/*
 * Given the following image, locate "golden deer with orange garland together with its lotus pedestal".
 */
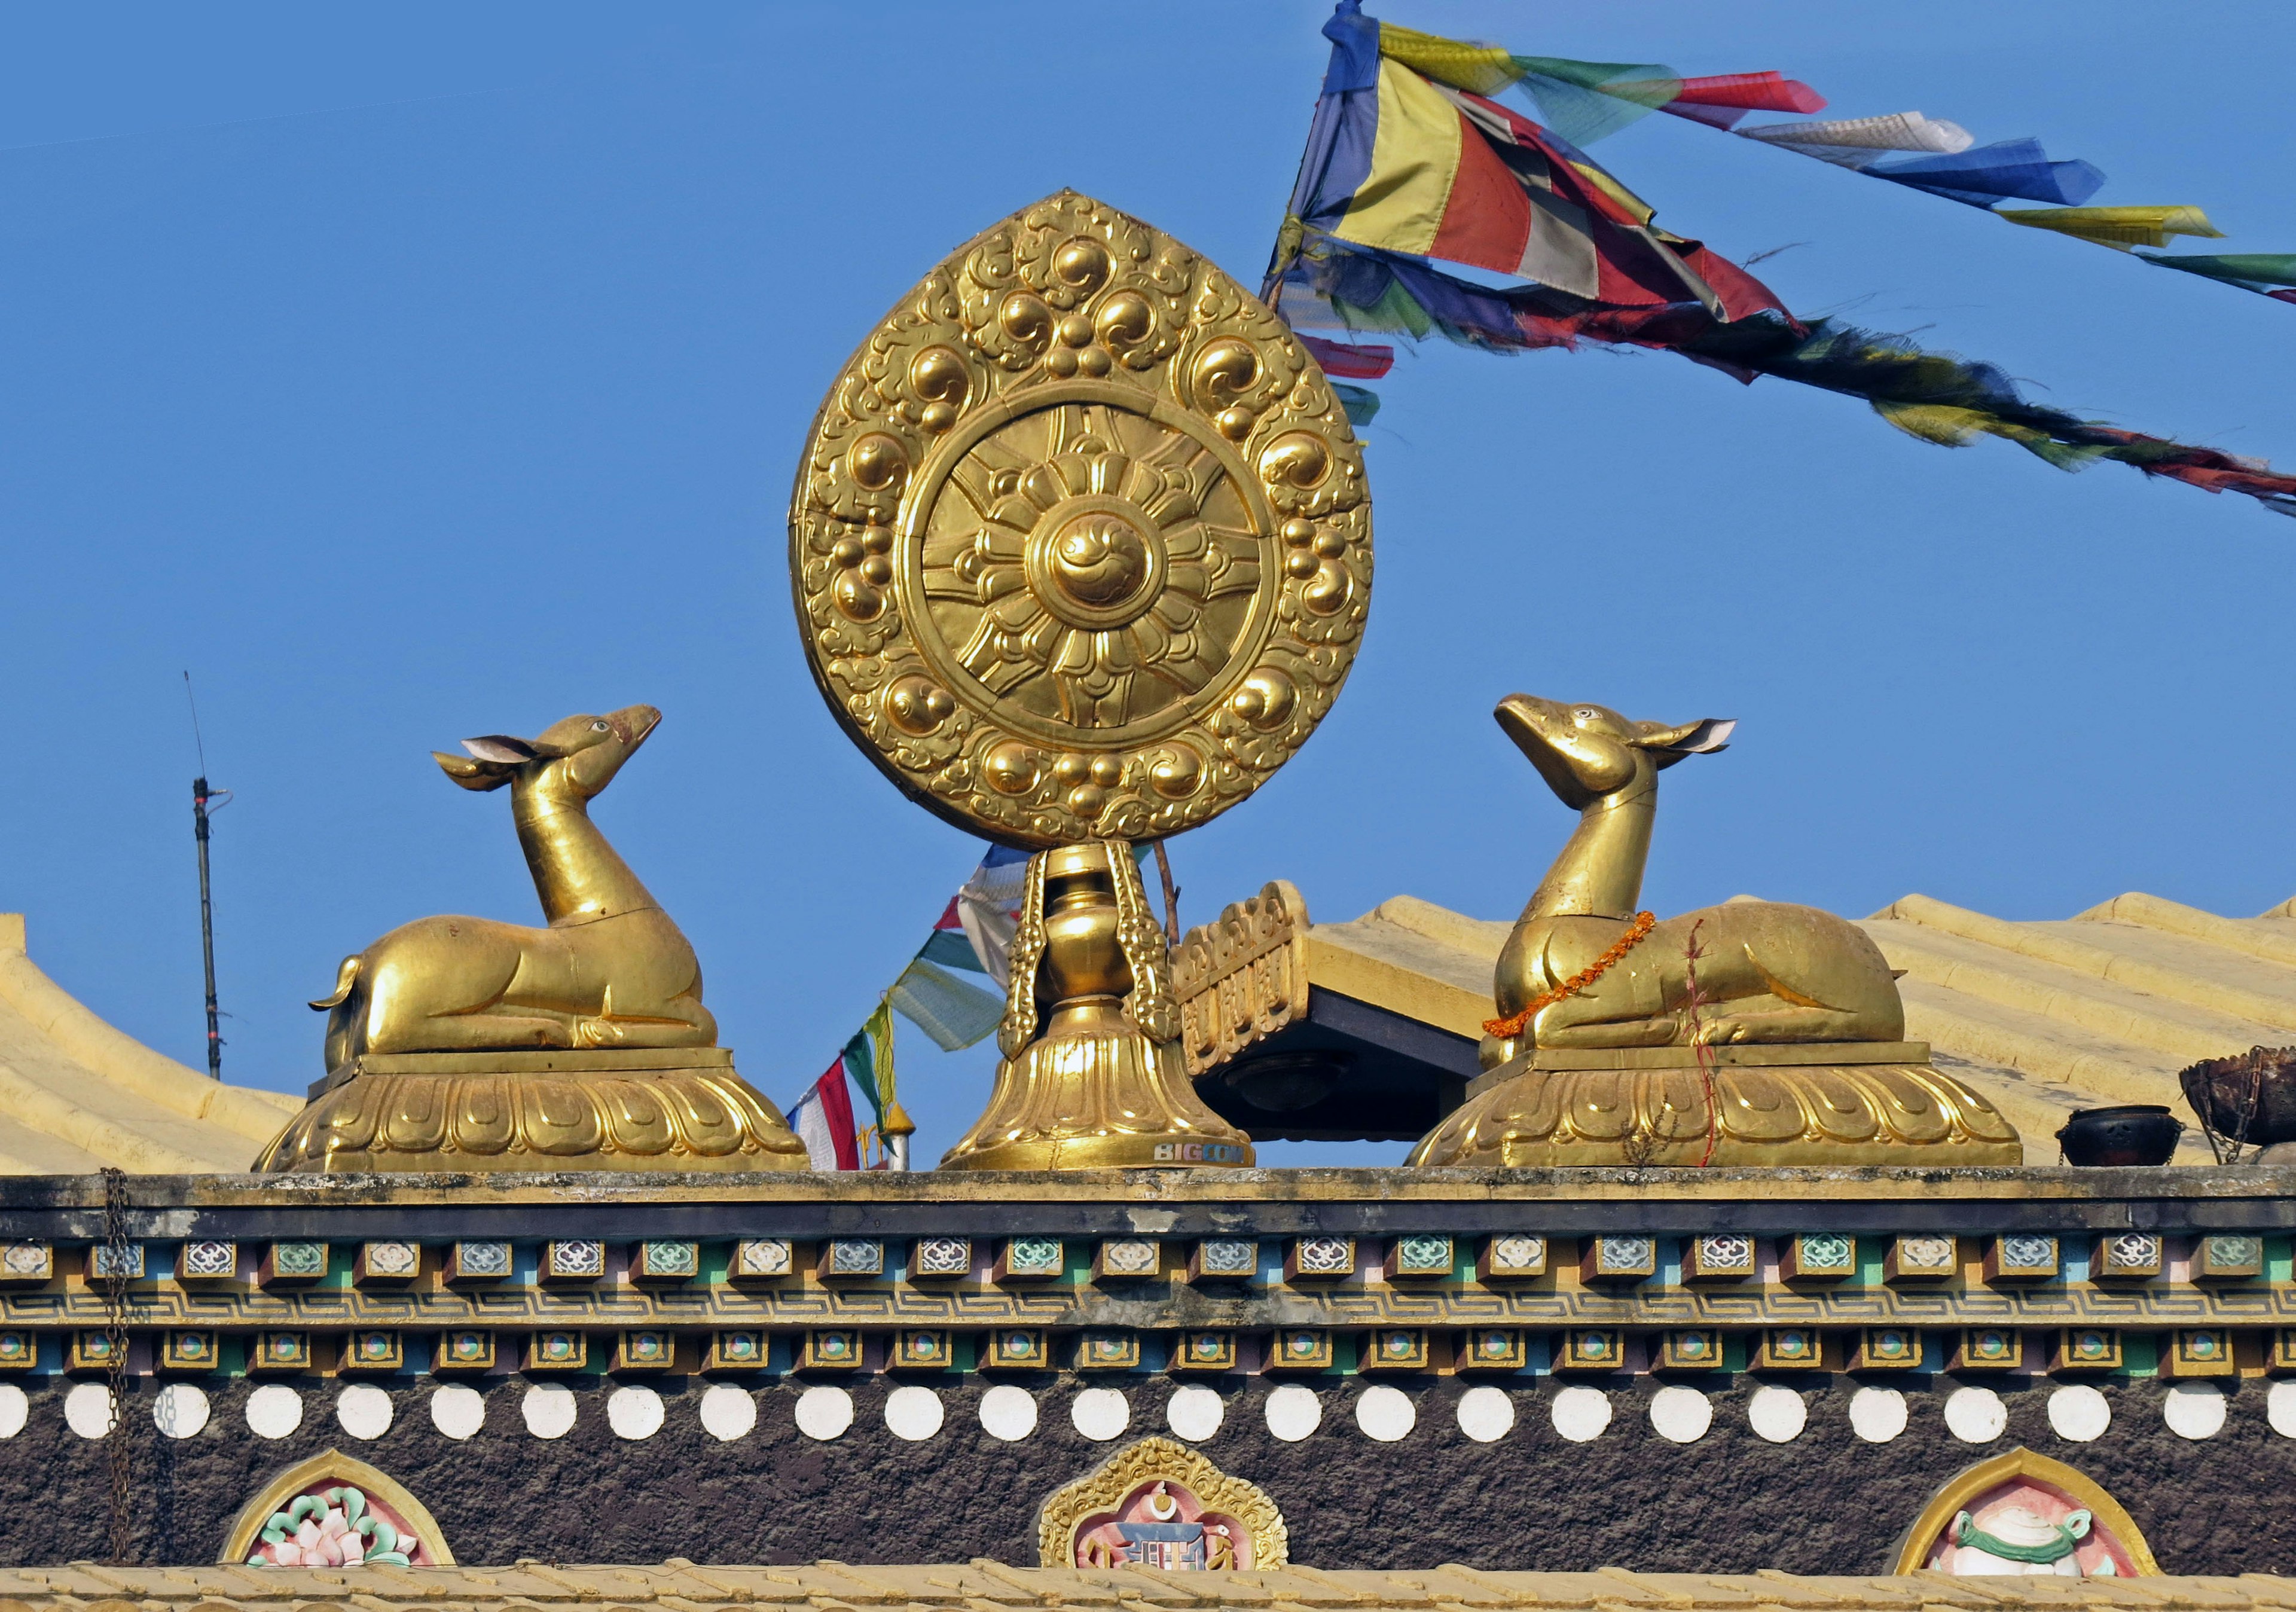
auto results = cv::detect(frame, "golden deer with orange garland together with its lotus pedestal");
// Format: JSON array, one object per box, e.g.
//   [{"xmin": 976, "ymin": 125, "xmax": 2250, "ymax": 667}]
[{"xmin": 1412, "ymin": 694, "xmax": 2023, "ymax": 1169}]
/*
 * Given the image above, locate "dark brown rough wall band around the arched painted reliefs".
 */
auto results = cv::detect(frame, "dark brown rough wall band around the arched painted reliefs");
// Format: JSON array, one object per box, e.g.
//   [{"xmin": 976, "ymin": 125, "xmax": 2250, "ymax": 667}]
[{"xmin": 0, "ymin": 1378, "xmax": 2296, "ymax": 1573}]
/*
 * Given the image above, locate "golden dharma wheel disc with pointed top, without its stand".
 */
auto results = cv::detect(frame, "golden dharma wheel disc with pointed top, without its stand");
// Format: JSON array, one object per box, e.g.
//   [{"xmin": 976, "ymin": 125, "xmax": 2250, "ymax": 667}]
[{"xmin": 790, "ymin": 191, "xmax": 1370, "ymax": 847}]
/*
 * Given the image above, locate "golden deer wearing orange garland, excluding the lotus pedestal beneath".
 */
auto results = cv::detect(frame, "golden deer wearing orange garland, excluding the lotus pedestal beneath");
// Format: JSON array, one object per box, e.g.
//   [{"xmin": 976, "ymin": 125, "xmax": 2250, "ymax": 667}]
[{"xmin": 1483, "ymin": 694, "xmax": 1906, "ymax": 1068}]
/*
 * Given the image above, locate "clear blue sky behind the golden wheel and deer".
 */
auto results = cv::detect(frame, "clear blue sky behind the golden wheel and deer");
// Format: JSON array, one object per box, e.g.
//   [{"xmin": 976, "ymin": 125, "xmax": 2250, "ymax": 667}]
[{"xmin": 0, "ymin": 0, "xmax": 2296, "ymax": 1162}]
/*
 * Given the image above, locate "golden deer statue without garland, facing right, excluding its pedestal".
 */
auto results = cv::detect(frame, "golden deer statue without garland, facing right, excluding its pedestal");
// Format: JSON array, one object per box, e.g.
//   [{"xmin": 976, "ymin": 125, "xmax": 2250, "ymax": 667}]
[{"xmin": 310, "ymin": 705, "xmax": 716, "ymax": 1070}]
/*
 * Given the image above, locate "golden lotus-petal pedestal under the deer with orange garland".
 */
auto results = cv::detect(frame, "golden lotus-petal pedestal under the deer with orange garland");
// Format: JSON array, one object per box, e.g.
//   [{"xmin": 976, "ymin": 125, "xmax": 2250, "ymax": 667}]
[{"xmin": 1410, "ymin": 1040, "xmax": 2025, "ymax": 1169}]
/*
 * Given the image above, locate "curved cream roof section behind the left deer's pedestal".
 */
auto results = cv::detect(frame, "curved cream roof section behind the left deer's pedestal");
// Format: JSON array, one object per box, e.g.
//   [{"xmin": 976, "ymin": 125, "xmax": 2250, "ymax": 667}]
[{"xmin": 0, "ymin": 912, "xmax": 303, "ymax": 1176}]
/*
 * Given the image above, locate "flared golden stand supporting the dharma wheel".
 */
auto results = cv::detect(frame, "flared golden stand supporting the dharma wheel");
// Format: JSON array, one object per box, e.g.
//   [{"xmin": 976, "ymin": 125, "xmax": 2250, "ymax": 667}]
[{"xmin": 941, "ymin": 841, "xmax": 1251, "ymax": 1169}]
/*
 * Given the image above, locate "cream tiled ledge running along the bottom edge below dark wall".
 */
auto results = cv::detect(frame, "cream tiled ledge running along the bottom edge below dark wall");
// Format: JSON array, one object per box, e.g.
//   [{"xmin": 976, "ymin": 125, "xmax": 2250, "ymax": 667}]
[{"xmin": 0, "ymin": 1557, "xmax": 2296, "ymax": 1612}]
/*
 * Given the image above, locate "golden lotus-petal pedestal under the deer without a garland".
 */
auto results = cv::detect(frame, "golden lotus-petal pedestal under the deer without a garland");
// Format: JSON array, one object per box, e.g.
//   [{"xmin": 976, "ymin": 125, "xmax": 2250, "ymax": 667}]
[{"xmin": 255, "ymin": 1047, "xmax": 806, "ymax": 1171}]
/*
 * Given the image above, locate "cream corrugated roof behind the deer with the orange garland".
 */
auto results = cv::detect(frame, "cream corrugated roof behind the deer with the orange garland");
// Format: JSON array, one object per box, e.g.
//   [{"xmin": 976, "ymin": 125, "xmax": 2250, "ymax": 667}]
[{"xmin": 1304, "ymin": 896, "xmax": 2296, "ymax": 1164}]
